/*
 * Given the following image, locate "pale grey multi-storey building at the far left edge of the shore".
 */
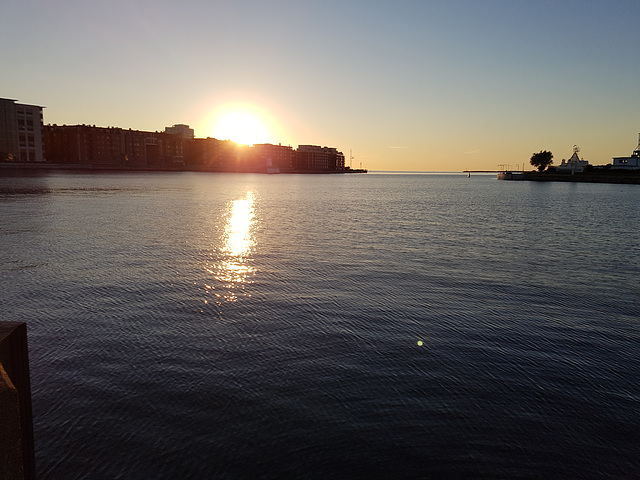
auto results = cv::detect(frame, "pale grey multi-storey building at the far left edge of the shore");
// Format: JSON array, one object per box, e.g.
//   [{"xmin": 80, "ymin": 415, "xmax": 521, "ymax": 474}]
[{"xmin": 0, "ymin": 98, "xmax": 45, "ymax": 162}]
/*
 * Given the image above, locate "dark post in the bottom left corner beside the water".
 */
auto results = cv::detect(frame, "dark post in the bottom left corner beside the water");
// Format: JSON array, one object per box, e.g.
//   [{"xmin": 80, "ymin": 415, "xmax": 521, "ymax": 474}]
[{"xmin": 0, "ymin": 322, "xmax": 35, "ymax": 480}]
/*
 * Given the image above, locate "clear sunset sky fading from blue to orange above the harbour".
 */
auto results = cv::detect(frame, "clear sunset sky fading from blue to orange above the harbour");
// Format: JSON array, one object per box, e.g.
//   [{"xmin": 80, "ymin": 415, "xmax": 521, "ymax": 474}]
[{"xmin": 0, "ymin": 0, "xmax": 640, "ymax": 171}]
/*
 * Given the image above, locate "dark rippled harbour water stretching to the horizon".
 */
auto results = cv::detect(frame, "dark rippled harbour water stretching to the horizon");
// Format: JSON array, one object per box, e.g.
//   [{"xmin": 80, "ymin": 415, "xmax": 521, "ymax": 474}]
[{"xmin": 0, "ymin": 173, "xmax": 640, "ymax": 479}]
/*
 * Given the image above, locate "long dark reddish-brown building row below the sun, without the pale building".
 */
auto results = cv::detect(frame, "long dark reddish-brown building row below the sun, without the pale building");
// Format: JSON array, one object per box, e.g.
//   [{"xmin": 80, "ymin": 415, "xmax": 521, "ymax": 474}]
[{"xmin": 43, "ymin": 125, "xmax": 345, "ymax": 173}]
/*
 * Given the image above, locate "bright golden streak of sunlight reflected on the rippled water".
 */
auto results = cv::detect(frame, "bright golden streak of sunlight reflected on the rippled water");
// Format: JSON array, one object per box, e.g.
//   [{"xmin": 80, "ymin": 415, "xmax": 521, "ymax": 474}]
[{"xmin": 206, "ymin": 192, "xmax": 256, "ymax": 302}]
